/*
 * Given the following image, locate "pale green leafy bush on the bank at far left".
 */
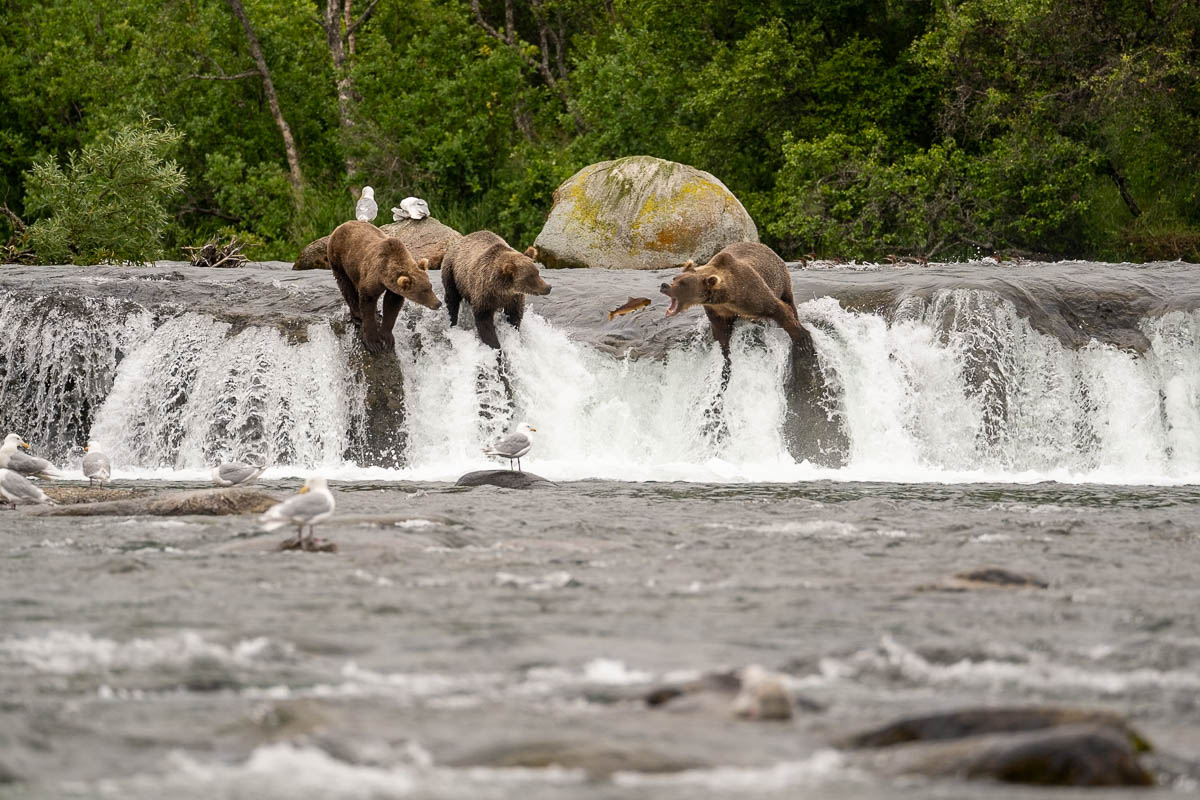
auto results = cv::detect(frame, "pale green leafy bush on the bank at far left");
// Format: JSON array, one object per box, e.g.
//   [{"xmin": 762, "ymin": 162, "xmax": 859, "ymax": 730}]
[{"xmin": 25, "ymin": 119, "xmax": 186, "ymax": 264}]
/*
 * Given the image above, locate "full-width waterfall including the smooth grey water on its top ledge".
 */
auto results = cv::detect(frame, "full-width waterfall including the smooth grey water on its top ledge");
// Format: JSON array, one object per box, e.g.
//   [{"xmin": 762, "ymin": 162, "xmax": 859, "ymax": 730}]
[{"xmin": 0, "ymin": 261, "xmax": 1200, "ymax": 483}]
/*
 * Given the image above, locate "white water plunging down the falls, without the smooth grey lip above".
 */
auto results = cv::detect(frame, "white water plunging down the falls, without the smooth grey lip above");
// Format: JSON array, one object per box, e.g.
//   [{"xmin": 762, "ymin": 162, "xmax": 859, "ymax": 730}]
[{"xmin": 0, "ymin": 266, "xmax": 1200, "ymax": 482}]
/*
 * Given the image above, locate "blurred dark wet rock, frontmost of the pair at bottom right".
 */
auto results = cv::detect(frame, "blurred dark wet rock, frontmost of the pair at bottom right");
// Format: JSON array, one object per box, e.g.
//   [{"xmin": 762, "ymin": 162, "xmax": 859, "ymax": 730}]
[{"xmin": 872, "ymin": 724, "xmax": 1154, "ymax": 787}]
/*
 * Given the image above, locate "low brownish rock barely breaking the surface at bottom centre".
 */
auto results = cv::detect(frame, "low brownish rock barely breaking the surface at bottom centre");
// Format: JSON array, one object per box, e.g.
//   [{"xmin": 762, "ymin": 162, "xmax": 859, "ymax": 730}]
[{"xmin": 450, "ymin": 741, "xmax": 702, "ymax": 778}]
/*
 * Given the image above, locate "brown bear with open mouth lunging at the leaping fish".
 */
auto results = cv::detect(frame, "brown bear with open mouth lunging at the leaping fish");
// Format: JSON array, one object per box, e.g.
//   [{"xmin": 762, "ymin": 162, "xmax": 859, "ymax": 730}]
[{"xmin": 660, "ymin": 242, "xmax": 814, "ymax": 361}]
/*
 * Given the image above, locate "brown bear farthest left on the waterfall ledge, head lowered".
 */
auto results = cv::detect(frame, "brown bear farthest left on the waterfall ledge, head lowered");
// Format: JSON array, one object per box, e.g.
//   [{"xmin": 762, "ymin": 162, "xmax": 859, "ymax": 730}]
[{"xmin": 329, "ymin": 221, "xmax": 442, "ymax": 353}]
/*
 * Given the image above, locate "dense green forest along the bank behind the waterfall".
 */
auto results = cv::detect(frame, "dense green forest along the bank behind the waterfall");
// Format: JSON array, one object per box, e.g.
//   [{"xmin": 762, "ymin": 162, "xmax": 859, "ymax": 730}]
[{"xmin": 0, "ymin": 0, "xmax": 1200, "ymax": 261}]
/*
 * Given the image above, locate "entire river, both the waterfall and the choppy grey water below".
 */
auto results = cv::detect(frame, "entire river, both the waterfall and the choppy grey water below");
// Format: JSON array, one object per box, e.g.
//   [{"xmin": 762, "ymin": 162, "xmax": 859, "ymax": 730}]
[{"xmin": 0, "ymin": 264, "xmax": 1200, "ymax": 799}]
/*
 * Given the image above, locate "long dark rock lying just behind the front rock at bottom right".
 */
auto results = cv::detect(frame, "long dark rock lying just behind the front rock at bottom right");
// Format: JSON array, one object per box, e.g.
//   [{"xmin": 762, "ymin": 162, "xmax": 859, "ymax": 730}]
[{"xmin": 838, "ymin": 708, "xmax": 1150, "ymax": 750}]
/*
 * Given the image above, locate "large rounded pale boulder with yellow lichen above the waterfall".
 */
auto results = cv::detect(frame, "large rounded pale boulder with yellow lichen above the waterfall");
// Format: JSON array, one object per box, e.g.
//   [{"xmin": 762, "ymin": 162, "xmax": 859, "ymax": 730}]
[{"xmin": 534, "ymin": 156, "xmax": 758, "ymax": 270}]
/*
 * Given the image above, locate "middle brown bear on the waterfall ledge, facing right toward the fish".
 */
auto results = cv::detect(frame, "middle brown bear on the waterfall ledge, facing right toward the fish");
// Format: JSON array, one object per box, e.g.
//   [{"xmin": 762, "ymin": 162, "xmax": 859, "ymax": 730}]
[{"xmin": 442, "ymin": 230, "xmax": 550, "ymax": 350}]
